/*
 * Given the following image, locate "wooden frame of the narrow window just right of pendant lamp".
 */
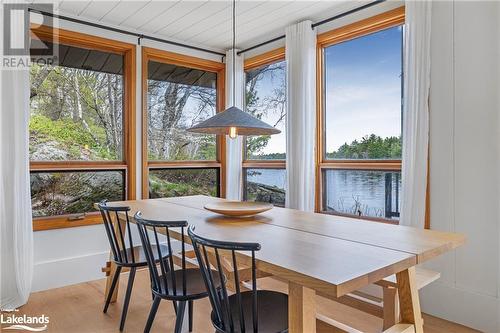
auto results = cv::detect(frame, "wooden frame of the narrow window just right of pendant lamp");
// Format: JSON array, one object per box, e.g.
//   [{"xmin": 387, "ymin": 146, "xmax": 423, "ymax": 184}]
[{"xmin": 241, "ymin": 47, "xmax": 286, "ymax": 198}]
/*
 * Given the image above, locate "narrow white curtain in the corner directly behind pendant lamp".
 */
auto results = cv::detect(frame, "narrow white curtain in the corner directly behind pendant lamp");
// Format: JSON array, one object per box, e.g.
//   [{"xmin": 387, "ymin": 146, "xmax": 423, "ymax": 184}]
[{"xmin": 226, "ymin": 50, "xmax": 245, "ymax": 200}]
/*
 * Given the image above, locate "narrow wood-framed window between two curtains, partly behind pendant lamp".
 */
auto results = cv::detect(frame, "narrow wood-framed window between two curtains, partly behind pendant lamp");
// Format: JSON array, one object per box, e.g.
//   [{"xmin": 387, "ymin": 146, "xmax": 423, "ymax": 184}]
[{"xmin": 243, "ymin": 48, "xmax": 286, "ymax": 206}]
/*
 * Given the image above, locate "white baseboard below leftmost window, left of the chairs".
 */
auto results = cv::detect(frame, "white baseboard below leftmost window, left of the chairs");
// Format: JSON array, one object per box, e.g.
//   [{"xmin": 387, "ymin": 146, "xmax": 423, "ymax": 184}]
[{"xmin": 32, "ymin": 251, "xmax": 109, "ymax": 292}]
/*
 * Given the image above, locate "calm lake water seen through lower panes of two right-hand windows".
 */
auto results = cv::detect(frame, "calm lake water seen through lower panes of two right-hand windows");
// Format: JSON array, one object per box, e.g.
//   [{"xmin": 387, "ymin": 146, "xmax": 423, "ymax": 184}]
[{"xmin": 247, "ymin": 169, "xmax": 401, "ymax": 217}]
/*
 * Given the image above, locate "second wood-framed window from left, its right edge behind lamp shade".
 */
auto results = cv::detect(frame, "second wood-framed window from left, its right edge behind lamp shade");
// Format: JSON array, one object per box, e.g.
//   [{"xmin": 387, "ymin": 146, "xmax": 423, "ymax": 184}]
[{"xmin": 143, "ymin": 48, "xmax": 224, "ymax": 198}]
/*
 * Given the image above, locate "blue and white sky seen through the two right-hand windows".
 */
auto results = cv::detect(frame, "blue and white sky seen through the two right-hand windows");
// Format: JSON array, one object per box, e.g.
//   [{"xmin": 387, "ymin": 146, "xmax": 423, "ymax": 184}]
[{"xmin": 250, "ymin": 27, "xmax": 402, "ymax": 154}]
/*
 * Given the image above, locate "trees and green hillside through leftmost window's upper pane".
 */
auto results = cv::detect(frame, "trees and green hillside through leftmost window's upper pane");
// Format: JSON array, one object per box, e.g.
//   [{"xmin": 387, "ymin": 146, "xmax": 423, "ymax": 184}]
[{"xmin": 30, "ymin": 64, "xmax": 123, "ymax": 160}]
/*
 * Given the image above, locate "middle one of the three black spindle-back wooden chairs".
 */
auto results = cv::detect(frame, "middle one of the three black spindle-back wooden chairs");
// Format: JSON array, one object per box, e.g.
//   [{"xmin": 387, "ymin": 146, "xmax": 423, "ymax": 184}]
[{"xmin": 134, "ymin": 212, "xmax": 220, "ymax": 333}]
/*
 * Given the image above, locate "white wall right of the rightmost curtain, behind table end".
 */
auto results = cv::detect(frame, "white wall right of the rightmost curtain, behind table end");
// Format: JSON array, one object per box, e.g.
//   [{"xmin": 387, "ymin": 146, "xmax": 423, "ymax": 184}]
[{"xmin": 422, "ymin": 2, "xmax": 500, "ymax": 332}]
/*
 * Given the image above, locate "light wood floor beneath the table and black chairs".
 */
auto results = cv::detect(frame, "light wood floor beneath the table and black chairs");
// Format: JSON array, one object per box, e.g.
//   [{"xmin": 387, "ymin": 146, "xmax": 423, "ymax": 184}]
[{"xmin": 12, "ymin": 270, "xmax": 477, "ymax": 333}]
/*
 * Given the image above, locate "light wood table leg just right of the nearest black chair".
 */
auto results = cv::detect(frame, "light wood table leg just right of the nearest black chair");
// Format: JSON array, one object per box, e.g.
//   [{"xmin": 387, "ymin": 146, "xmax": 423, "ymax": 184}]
[{"xmin": 288, "ymin": 282, "xmax": 316, "ymax": 333}]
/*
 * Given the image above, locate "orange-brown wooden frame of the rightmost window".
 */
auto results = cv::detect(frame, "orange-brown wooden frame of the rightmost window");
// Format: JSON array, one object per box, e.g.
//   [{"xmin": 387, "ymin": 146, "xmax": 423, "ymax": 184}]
[{"xmin": 315, "ymin": 6, "xmax": 405, "ymax": 224}]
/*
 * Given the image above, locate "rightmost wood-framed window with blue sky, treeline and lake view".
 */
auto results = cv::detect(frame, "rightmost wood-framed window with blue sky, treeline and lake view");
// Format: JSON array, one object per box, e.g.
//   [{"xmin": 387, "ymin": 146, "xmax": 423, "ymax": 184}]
[{"xmin": 318, "ymin": 8, "xmax": 404, "ymax": 223}]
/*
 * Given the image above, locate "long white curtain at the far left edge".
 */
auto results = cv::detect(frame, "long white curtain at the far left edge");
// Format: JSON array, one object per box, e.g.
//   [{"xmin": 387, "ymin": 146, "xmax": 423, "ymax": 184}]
[{"xmin": 0, "ymin": 8, "xmax": 33, "ymax": 310}]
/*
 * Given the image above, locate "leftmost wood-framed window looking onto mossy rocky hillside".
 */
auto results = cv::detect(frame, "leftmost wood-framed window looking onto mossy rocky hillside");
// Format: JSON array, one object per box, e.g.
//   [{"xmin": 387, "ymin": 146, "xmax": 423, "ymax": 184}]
[{"xmin": 29, "ymin": 27, "xmax": 135, "ymax": 230}]
